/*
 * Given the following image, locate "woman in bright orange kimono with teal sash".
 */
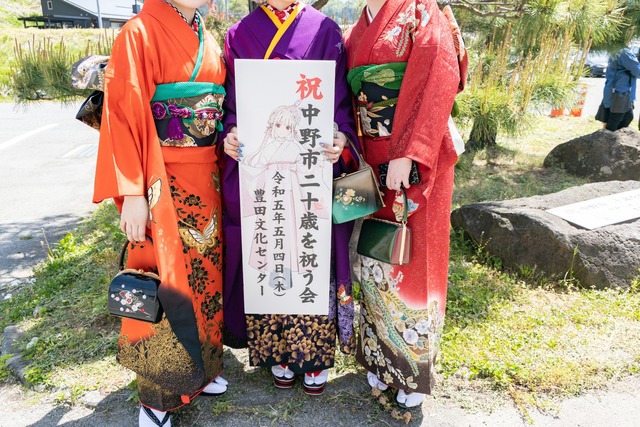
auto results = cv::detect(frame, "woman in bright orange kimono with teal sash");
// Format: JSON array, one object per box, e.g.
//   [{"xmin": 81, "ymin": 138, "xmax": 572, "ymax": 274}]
[{"xmin": 93, "ymin": 0, "xmax": 227, "ymax": 426}]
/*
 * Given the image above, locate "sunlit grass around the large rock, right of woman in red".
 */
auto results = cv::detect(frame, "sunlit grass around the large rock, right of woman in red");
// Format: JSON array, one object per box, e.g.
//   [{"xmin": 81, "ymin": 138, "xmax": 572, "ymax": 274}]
[{"xmin": 440, "ymin": 117, "xmax": 640, "ymax": 409}]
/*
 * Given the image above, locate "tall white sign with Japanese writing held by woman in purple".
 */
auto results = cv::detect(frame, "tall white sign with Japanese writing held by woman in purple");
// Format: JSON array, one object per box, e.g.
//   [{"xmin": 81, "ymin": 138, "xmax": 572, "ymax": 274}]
[{"xmin": 235, "ymin": 60, "xmax": 335, "ymax": 315}]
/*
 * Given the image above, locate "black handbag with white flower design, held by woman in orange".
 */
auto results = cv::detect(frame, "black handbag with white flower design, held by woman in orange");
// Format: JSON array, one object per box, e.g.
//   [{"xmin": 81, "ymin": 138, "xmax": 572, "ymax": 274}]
[{"xmin": 107, "ymin": 237, "xmax": 163, "ymax": 323}]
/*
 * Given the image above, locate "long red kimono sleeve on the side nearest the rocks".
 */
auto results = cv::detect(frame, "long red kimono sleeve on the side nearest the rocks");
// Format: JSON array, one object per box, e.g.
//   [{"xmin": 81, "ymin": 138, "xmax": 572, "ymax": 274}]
[{"xmin": 389, "ymin": 1, "xmax": 460, "ymax": 194}]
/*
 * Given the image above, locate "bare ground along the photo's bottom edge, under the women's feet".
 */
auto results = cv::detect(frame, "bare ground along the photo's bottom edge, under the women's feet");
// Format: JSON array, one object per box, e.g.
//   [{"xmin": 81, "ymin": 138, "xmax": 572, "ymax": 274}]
[{"xmin": 0, "ymin": 349, "xmax": 640, "ymax": 427}]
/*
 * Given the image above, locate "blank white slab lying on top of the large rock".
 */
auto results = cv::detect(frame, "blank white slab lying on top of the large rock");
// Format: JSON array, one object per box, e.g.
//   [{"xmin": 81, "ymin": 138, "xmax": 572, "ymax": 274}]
[{"xmin": 547, "ymin": 190, "xmax": 640, "ymax": 230}]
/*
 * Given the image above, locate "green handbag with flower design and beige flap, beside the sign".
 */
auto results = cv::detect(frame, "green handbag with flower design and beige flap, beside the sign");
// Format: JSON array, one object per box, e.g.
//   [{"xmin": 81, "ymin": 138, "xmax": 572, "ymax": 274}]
[{"xmin": 331, "ymin": 153, "xmax": 384, "ymax": 224}]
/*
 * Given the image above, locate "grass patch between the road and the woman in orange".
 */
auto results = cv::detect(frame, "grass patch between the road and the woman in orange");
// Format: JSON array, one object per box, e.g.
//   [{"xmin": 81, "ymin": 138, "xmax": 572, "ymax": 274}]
[{"xmin": 0, "ymin": 203, "xmax": 130, "ymax": 394}]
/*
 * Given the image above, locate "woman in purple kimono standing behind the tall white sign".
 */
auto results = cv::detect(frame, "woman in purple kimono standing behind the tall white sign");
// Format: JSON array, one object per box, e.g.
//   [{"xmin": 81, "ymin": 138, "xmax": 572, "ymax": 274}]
[{"xmin": 223, "ymin": 0, "xmax": 359, "ymax": 394}]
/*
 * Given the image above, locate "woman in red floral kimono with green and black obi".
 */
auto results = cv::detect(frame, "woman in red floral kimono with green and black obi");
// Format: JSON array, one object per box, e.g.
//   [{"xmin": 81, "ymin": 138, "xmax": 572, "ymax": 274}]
[{"xmin": 345, "ymin": 0, "xmax": 466, "ymax": 407}]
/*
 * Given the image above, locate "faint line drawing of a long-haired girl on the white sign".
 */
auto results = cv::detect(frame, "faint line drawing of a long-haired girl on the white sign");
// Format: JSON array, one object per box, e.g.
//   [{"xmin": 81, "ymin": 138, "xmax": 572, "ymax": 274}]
[{"xmin": 242, "ymin": 103, "xmax": 326, "ymax": 296}]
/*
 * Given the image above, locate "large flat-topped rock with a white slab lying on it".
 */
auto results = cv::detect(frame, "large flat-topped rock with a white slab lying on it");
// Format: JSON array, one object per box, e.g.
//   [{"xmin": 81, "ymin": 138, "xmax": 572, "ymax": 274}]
[{"xmin": 451, "ymin": 181, "xmax": 640, "ymax": 288}]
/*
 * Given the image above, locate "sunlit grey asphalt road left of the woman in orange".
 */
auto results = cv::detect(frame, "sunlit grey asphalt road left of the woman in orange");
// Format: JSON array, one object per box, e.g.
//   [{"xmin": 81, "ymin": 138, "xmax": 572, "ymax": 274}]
[{"xmin": 0, "ymin": 102, "xmax": 98, "ymax": 294}]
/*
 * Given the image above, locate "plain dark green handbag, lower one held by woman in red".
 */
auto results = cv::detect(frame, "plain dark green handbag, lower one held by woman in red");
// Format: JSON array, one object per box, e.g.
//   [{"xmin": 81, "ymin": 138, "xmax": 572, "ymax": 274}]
[{"xmin": 356, "ymin": 188, "xmax": 411, "ymax": 265}]
